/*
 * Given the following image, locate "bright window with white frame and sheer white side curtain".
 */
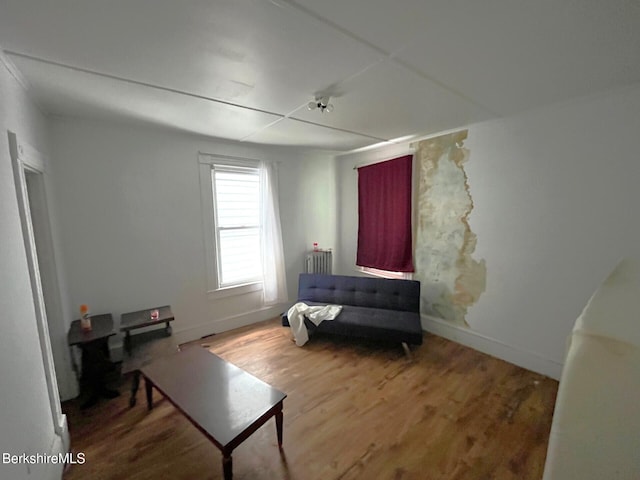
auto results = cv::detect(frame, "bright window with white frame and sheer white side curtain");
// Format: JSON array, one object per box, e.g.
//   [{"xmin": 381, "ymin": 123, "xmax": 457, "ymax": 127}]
[{"xmin": 198, "ymin": 153, "xmax": 288, "ymax": 306}]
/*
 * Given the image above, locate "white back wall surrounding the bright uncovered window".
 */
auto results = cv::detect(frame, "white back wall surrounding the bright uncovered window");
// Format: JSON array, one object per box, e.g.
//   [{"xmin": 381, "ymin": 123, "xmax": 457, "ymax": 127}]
[{"xmin": 52, "ymin": 118, "xmax": 335, "ymax": 345}]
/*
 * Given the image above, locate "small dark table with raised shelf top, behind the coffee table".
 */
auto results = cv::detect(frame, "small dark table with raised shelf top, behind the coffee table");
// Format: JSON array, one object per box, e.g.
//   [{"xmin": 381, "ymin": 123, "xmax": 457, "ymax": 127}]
[{"xmin": 120, "ymin": 305, "xmax": 179, "ymax": 407}]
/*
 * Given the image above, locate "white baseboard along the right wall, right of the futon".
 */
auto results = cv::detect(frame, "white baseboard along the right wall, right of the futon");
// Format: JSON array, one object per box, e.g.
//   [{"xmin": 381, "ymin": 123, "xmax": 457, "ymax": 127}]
[{"xmin": 421, "ymin": 315, "xmax": 563, "ymax": 380}]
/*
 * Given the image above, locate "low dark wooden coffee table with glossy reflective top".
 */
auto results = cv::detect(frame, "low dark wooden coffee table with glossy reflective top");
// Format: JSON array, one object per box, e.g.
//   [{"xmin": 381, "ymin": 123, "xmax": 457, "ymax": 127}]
[{"xmin": 141, "ymin": 347, "xmax": 287, "ymax": 480}]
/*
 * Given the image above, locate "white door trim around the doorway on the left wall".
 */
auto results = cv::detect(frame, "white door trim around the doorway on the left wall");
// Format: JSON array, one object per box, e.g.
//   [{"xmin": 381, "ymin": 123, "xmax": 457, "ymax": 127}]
[{"xmin": 9, "ymin": 132, "xmax": 70, "ymax": 454}]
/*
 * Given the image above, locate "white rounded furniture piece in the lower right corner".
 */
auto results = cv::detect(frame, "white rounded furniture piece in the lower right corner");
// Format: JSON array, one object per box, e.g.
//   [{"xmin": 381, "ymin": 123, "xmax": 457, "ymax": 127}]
[{"xmin": 543, "ymin": 259, "xmax": 640, "ymax": 480}]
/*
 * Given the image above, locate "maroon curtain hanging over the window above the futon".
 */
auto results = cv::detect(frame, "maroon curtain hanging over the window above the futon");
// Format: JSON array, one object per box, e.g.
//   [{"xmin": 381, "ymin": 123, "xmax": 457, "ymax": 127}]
[{"xmin": 356, "ymin": 155, "xmax": 413, "ymax": 272}]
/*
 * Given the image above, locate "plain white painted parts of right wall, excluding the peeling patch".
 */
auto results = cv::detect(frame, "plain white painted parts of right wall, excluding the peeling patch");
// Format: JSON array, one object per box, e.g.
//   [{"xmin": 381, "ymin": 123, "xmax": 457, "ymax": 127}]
[{"xmin": 337, "ymin": 85, "xmax": 640, "ymax": 378}]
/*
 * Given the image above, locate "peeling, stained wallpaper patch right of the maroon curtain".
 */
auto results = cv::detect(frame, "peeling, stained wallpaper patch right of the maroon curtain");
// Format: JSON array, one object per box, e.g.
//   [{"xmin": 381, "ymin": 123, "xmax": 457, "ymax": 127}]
[{"xmin": 414, "ymin": 130, "xmax": 486, "ymax": 325}]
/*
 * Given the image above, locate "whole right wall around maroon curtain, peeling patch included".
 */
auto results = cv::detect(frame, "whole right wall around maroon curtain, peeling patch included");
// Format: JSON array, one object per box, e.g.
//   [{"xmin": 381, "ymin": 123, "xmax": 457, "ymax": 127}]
[{"xmin": 334, "ymin": 83, "xmax": 640, "ymax": 379}]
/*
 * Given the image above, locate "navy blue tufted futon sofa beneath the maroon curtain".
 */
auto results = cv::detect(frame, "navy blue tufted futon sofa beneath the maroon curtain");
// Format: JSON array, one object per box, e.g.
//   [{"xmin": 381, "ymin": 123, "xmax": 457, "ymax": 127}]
[{"xmin": 282, "ymin": 273, "xmax": 422, "ymax": 348}]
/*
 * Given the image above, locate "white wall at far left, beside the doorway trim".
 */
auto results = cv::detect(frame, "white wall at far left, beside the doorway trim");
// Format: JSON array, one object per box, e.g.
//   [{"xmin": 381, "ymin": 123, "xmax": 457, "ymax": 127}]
[{"xmin": 0, "ymin": 57, "xmax": 62, "ymax": 479}]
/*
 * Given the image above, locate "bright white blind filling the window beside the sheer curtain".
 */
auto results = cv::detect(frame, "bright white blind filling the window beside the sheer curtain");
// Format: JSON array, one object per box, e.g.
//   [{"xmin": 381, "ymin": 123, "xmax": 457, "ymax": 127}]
[{"xmin": 212, "ymin": 165, "xmax": 262, "ymax": 287}]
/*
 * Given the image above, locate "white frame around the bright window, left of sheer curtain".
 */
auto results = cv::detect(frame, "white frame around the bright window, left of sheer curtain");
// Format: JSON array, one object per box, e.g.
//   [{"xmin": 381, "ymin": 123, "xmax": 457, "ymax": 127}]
[{"xmin": 198, "ymin": 153, "xmax": 262, "ymax": 298}]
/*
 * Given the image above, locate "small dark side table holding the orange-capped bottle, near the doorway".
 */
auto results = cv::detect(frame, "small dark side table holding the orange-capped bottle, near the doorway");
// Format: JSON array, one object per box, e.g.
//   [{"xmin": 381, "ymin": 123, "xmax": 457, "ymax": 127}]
[{"xmin": 67, "ymin": 313, "xmax": 119, "ymax": 408}]
